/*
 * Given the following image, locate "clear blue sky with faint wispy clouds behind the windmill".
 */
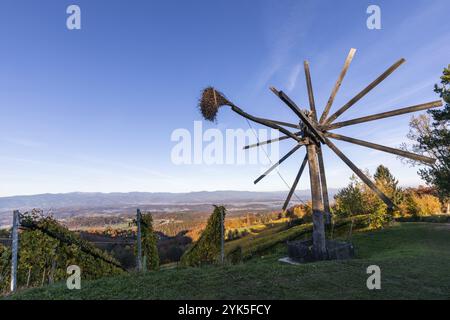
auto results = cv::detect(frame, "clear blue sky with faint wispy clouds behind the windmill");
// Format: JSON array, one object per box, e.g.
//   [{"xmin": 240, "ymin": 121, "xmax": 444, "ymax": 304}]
[{"xmin": 0, "ymin": 0, "xmax": 450, "ymax": 196}]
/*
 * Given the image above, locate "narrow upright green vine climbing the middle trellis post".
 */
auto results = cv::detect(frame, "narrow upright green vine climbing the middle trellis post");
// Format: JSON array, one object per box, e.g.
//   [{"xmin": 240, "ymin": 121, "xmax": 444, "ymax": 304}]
[{"xmin": 141, "ymin": 213, "xmax": 159, "ymax": 270}]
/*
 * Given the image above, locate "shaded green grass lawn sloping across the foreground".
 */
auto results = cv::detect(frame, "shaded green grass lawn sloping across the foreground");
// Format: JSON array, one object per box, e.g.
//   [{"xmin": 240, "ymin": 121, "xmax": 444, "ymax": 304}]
[{"xmin": 7, "ymin": 223, "xmax": 450, "ymax": 299}]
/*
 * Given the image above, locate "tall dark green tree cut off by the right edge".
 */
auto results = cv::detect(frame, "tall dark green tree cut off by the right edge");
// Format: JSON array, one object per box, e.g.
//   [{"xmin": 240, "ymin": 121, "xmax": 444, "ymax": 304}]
[{"xmin": 403, "ymin": 65, "xmax": 450, "ymax": 209}]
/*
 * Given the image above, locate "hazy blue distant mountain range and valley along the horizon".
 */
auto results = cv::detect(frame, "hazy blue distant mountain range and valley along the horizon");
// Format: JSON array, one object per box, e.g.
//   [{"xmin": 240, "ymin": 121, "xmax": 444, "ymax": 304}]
[{"xmin": 0, "ymin": 189, "xmax": 336, "ymax": 226}]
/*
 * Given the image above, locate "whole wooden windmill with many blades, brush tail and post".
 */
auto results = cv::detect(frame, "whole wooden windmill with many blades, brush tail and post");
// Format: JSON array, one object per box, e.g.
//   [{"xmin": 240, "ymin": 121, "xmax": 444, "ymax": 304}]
[{"xmin": 199, "ymin": 49, "xmax": 442, "ymax": 258}]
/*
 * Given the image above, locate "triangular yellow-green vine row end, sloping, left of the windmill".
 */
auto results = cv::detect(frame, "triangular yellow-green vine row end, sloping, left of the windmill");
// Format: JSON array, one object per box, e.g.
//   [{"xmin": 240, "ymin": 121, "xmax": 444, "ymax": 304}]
[{"xmin": 180, "ymin": 206, "xmax": 226, "ymax": 267}]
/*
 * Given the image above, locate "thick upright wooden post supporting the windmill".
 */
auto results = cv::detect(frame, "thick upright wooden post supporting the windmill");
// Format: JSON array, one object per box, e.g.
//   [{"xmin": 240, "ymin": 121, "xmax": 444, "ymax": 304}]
[{"xmin": 307, "ymin": 143, "xmax": 327, "ymax": 260}]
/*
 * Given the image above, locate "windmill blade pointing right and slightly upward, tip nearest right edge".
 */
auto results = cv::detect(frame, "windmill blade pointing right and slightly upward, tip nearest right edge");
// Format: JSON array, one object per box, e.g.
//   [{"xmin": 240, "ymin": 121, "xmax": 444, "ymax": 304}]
[{"xmin": 324, "ymin": 100, "xmax": 443, "ymax": 130}]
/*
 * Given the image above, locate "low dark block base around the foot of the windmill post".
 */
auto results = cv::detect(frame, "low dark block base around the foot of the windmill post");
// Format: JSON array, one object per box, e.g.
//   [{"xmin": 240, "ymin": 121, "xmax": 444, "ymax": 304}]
[{"xmin": 287, "ymin": 240, "xmax": 355, "ymax": 263}]
